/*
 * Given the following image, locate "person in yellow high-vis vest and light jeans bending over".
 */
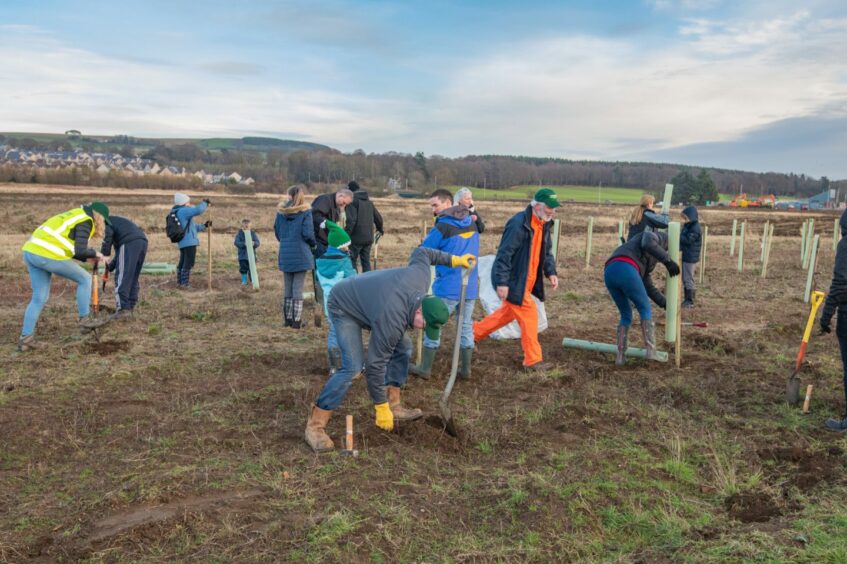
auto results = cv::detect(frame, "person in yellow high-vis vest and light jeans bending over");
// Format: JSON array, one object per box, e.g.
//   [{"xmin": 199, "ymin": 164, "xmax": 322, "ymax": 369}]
[{"xmin": 18, "ymin": 202, "xmax": 109, "ymax": 352}]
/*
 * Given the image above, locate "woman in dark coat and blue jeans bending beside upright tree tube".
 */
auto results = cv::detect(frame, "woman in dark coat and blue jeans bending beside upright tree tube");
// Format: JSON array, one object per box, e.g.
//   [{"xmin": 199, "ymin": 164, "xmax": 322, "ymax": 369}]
[{"xmin": 603, "ymin": 231, "xmax": 679, "ymax": 366}]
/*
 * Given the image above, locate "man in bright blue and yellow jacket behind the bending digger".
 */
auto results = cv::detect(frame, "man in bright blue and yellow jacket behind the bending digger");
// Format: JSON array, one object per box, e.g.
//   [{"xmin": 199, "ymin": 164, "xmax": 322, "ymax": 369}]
[{"xmin": 409, "ymin": 188, "xmax": 479, "ymax": 380}]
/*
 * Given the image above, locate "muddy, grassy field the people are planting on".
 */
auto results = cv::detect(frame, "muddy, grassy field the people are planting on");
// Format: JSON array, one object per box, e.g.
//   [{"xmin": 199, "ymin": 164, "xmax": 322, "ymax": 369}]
[{"xmin": 0, "ymin": 185, "xmax": 847, "ymax": 562}]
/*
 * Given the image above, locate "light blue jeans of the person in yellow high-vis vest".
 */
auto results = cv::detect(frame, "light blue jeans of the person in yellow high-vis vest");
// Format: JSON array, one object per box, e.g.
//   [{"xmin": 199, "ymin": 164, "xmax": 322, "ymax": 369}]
[{"xmin": 21, "ymin": 251, "xmax": 91, "ymax": 337}]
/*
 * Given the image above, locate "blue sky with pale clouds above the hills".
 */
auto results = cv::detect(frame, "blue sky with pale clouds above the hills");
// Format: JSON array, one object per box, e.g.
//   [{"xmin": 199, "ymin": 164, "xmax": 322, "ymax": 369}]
[{"xmin": 0, "ymin": 0, "xmax": 847, "ymax": 179}]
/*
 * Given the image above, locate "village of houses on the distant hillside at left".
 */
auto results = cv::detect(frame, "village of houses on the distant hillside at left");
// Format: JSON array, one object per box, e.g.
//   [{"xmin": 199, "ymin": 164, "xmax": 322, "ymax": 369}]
[{"xmin": 0, "ymin": 145, "xmax": 255, "ymax": 186}]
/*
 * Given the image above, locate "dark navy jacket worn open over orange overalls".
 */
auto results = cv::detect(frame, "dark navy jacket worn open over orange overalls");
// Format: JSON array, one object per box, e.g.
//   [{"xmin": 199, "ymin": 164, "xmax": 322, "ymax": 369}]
[{"xmin": 491, "ymin": 206, "xmax": 556, "ymax": 305}]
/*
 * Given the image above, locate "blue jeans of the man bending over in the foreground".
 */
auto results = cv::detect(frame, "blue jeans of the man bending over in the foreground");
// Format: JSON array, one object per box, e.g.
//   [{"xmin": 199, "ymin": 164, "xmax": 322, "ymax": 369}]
[{"xmin": 315, "ymin": 308, "xmax": 412, "ymax": 411}]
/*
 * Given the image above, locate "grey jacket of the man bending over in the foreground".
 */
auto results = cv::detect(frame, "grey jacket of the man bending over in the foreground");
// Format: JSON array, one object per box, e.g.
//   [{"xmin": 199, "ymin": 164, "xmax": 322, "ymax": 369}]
[{"xmin": 327, "ymin": 247, "xmax": 451, "ymax": 403}]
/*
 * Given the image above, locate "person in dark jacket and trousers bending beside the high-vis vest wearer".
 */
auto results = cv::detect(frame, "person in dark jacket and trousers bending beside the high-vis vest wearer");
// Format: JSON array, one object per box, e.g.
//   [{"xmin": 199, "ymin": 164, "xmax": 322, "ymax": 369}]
[{"xmin": 100, "ymin": 215, "xmax": 147, "ymax": 319}]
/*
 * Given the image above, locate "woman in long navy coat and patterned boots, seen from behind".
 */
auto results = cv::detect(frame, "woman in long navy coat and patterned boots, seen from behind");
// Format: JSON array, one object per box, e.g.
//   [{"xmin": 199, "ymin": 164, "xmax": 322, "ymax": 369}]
[{"xmin": 274, "ymin": 186, "xmax": 317, "ymax": 329}]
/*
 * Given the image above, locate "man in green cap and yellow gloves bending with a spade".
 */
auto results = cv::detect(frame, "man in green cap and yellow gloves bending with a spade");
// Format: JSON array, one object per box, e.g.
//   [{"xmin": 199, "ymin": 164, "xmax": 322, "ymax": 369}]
[{"xmin": 306, "ymin": 247, "xmax": 476, "ymax": 452}]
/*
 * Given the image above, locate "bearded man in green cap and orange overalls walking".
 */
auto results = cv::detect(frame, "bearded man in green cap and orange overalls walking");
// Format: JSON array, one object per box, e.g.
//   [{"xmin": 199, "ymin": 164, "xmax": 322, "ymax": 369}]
[{"xmin": 474, "ymin": 188, "xmax": 559, "ymax": 371}]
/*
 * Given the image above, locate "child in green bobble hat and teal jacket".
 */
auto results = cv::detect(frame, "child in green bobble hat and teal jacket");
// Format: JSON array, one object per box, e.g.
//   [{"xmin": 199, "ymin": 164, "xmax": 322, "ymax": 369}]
[{"xmin": 315, "ymin": 219, "xmax": 356, "ymax": 374}]
